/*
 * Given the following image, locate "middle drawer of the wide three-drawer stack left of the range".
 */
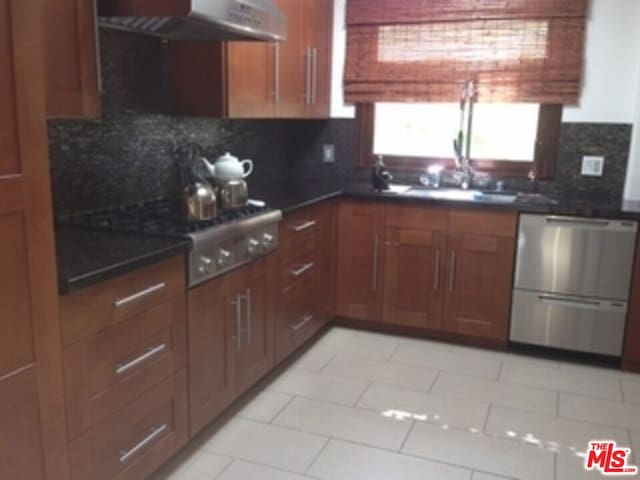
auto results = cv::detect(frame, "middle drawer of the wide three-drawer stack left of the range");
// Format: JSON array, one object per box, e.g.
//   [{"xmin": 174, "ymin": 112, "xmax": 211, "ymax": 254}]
[{"xmin": 64, "ymin": 295, "xmax": 186, "ymax": 439}]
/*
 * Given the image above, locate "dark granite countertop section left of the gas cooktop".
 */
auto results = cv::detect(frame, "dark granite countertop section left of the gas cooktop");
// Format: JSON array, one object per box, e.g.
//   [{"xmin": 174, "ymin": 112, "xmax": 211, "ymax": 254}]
[{"xmin": 56, "ymin": 227, "xmax": 191, "ymax": 295}]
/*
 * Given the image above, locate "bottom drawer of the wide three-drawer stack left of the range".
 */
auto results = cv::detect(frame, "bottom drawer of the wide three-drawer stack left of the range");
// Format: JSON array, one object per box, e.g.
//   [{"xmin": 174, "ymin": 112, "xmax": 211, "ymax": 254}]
[{"xmin": 70, "ymin": 370, "xmax": 188, "ymax": 480}]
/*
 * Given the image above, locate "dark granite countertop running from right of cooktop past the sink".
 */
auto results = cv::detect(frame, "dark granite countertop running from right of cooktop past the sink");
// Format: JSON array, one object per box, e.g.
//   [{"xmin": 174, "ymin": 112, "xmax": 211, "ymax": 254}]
[{"xmin": 250, "ymin": 180, "xmax": 640, "ymax": 221}]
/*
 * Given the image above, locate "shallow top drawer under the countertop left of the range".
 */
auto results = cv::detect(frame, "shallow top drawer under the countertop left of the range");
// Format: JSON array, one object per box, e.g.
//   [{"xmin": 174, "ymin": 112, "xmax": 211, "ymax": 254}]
[{"xmin": 60, "ymin": 256, "xmax": 186, "ymax": 346}]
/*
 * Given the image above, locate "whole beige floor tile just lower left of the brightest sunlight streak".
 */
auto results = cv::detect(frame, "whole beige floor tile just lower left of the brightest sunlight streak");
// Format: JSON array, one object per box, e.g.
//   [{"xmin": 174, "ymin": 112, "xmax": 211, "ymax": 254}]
[{"xmin": 273, "ymin": 398, "xmax": 411, "ymax": 450}]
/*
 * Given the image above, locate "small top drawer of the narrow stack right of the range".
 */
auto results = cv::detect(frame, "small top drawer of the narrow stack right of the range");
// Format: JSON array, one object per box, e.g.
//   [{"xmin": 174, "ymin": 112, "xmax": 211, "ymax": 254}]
[{"xmin": 280, "ymin": 208, "xmax": 318, "ymax": 264}]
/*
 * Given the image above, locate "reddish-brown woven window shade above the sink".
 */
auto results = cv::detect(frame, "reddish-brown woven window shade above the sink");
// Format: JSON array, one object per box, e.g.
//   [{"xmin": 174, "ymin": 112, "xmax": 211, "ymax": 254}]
[{"xmin": 345, "ymin": 0, "xmax": 587, "ymax": 105}]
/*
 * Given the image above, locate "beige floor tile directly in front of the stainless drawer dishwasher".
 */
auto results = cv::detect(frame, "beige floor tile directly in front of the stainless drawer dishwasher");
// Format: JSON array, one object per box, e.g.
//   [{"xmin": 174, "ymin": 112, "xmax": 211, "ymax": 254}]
[{"xmin": 500, "ymin": 362, "xmax": 622, "ymax": 400}]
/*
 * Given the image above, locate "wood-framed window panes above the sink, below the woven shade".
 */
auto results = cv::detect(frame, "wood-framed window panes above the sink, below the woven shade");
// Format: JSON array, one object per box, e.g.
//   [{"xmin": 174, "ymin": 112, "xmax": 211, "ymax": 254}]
[{"xmin": 358, "ymin": 103, "xmax": 562, "ymax": 178}]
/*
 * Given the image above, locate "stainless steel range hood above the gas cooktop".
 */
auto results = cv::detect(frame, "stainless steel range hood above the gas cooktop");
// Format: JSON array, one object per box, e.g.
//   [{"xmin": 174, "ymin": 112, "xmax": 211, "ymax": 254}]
[{"xmin": 98, "ymin": 0, "xmax": 287, "ymax": 41}]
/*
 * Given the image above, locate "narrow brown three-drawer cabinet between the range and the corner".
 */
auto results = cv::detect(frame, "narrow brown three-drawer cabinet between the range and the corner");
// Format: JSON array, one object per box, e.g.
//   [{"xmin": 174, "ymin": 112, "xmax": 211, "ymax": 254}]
[{"xmin": 276, "ymin": 202, "xmax": 336, "ymax": 361}]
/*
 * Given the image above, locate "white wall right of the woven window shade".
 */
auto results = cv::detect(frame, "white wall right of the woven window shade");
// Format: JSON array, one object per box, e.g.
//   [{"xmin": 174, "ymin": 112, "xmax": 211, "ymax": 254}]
[{"xmin": 563, "ymin": 0, "xmax": 640, "ymax": 123}]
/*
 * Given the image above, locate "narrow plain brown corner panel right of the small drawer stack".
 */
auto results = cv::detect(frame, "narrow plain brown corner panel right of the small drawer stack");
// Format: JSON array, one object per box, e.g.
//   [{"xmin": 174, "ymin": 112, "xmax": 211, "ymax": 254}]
[{"xmin": 314, "ymin": 203, "xmax": 337, "ymax": 326}]
